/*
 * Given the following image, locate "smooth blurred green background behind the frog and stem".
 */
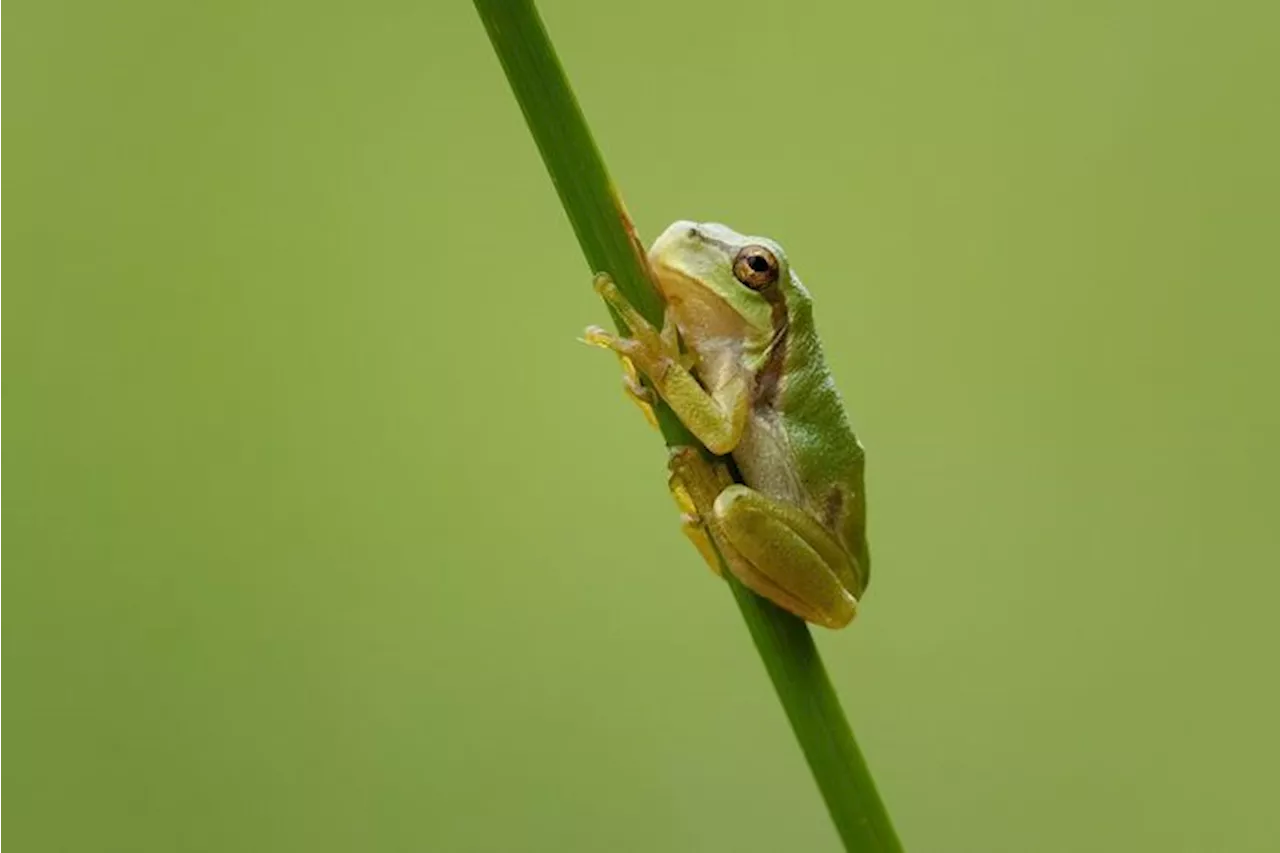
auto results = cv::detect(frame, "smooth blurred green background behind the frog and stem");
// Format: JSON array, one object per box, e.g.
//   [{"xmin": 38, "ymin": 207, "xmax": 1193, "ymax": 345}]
[{"xmin": 0, "ymin": 0, "xmax": 1280, "ymax": 853}]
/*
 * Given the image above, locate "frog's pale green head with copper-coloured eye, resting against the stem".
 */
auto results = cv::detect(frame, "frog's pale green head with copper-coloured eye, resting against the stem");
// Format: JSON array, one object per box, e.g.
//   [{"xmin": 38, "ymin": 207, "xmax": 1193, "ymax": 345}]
[{"xmin": 649, "ymin": 220, "xmax": 791, "ymax": 348}]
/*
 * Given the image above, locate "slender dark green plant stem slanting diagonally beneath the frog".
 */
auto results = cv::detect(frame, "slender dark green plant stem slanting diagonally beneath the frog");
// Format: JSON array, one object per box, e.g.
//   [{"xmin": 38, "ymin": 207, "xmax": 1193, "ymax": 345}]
[{"xmin": 475, "ymin": 0, "xmax": 902, "ymax": 853}]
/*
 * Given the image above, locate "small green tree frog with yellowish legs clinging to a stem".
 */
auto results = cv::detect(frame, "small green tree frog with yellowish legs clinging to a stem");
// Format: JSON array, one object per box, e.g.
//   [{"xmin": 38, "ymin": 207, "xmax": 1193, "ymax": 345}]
[{"xmin": 584, "ymin": 222, "xmax": 870, "ymax": 628}]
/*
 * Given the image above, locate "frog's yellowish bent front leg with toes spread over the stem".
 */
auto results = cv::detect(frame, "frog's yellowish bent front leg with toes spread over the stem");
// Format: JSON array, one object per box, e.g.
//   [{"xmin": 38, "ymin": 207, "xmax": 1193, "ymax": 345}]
[{"xmin": 584, "ymin": 274, "xmax": 749, "ymax": 456}]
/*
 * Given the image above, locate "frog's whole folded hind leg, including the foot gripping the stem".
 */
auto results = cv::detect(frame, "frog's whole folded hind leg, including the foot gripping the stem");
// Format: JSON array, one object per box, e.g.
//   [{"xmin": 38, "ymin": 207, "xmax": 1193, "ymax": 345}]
[{"xmin": 669, "ymin": 447, "xmax": 863, "ymax": 628}]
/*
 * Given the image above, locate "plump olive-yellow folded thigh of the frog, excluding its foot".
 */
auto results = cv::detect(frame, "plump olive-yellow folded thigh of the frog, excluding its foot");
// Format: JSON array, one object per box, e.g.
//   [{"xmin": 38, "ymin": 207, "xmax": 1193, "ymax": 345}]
[{"xmin": 714, "ymin": 485, "xmax": 858, "ymax": 628}]
